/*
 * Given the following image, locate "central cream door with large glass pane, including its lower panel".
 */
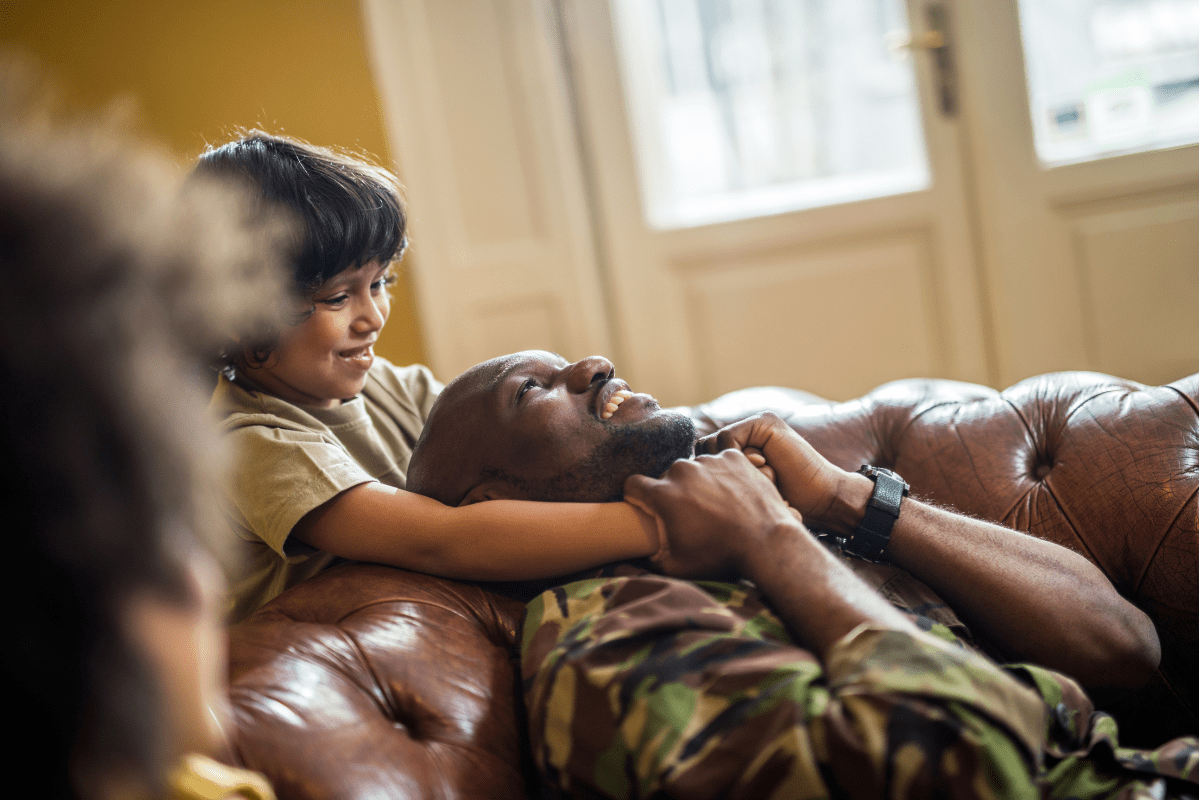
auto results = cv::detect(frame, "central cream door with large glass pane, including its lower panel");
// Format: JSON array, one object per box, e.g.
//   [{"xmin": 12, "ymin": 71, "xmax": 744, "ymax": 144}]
[{"xmin": 562, "ymin": 0, "xmax": 995, "ymax": 403}]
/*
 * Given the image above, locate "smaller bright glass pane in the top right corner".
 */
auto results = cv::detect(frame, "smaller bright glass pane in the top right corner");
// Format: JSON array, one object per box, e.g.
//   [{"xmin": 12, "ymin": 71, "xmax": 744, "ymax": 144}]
[{"xmin": 1020, "ymin": 0, "xmax": 1200, "ymax": 167}]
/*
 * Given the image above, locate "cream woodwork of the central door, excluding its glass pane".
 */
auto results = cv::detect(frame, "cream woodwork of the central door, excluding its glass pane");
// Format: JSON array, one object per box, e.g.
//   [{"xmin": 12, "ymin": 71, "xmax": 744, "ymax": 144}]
[{"xmin": 563, "ymin": 0, "xmax": 989, "ymax": 403}]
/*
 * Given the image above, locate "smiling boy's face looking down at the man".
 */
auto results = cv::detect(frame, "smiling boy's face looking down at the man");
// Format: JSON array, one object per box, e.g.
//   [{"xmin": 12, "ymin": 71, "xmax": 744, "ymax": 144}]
[{"xmin": 247, "ymin": 261, "xmax": 391, "ymax": 408}]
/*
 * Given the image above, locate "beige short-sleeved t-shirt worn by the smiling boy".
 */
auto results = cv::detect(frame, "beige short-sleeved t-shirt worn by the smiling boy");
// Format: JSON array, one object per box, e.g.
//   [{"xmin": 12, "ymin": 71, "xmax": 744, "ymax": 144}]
[{"xmin": 209, "ymin": 357, "xmax": 442, "ymax": 622}]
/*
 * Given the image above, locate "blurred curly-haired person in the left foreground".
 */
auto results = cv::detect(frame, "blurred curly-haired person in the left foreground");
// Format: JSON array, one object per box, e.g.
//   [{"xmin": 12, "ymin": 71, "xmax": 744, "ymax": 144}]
[{"xmin": 0, "ymin": 64, "xmax": 282, "ymax": 800}]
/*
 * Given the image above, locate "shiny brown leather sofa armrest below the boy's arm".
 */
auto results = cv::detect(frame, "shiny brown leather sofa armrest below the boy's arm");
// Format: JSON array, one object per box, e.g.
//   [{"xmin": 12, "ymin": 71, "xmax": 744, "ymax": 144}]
[{"xmin": 229, "ymin": 564, "xmax": 526, "ymax": 800}]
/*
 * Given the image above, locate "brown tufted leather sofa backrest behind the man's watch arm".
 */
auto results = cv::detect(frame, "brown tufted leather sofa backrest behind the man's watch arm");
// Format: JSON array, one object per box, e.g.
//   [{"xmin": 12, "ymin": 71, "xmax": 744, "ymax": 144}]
[{"xmin": 694, "ymin": 372, "xmax": 1200, "ymax": 744}]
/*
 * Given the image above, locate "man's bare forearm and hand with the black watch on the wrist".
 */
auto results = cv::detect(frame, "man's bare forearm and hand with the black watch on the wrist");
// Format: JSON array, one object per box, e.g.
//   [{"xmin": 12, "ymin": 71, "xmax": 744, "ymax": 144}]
[{"xmin": 697, "ymin": 414, "xmax": 1159, "ymax": 692}]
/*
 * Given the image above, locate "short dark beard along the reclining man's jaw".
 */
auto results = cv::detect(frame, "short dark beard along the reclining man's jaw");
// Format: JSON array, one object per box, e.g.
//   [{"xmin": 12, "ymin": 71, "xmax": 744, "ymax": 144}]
[{"xmin": 488, "ymin": 413, "xmax": 696, "ymax": 503}]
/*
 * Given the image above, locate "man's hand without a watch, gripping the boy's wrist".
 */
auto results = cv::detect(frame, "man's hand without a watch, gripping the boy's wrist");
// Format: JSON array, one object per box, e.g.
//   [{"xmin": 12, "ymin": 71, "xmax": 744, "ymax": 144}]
[{"xmin": 625, "ymin": 450, "xmax": 805, "ymax": 578}]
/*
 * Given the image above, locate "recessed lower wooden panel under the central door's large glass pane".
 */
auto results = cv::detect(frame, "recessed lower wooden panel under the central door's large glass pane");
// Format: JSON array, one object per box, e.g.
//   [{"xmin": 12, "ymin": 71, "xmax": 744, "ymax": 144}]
[{"xmin": 673, "ymin": 230, "xmax": 947, "ymax": 397}]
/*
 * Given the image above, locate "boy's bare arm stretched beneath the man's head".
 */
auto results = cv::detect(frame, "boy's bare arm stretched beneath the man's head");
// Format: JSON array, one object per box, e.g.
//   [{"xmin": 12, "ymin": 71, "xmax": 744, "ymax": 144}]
[{"xmin": 292, "ymin": 483, "xmax": 658, "ymax": 581}]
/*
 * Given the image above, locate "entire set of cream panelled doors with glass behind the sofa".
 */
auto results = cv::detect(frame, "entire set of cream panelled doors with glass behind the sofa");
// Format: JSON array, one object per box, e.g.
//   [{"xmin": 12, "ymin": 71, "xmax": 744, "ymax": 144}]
[{"xmin": 364, "ymin": 0, "xmax": 1198, "ymax": 403}]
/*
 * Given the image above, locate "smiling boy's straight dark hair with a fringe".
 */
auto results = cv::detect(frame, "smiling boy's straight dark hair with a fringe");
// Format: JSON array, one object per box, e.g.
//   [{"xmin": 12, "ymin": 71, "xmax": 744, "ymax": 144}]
[{"xmin": 194, "ymin": 131, "xmax": 408, "ymax": 366}]
